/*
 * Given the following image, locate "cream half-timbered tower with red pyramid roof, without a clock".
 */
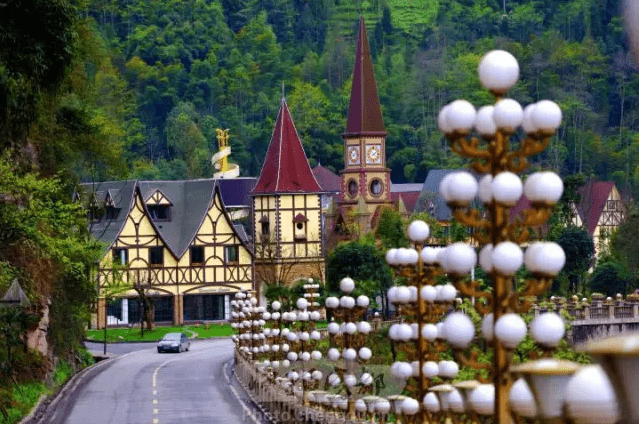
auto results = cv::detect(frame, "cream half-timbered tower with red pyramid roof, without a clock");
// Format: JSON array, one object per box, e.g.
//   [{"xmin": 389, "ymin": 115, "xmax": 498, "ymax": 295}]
[{"xmin": 251, "ymin": 97, "xmax": 324, "ymax": 300}]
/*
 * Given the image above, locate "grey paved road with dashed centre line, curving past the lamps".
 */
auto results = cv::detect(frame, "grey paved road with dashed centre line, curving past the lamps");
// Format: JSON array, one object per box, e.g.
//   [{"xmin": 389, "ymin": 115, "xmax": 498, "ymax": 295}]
[{"xmin": 40, "ymin": 339, "xmax": 252, "ymax": 424}]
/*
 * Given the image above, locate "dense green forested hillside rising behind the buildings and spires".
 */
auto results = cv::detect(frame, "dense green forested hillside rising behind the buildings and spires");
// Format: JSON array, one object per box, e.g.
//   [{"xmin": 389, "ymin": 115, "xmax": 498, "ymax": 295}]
[{"xmin": 72, "ymin": 0, "xmax": 639, "ymax": 195}]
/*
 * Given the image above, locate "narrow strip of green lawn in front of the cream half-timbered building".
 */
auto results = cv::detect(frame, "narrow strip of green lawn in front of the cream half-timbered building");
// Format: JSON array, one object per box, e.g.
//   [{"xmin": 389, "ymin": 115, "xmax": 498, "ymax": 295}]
[{"xmin": 86, "ymin": 323, "xmax": 233, "ymax": 342}]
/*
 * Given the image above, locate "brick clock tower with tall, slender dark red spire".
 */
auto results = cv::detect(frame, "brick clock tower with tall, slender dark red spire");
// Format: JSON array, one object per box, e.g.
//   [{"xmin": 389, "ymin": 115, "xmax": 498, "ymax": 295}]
[{"xmin": 339, "ymin": 17, "xmax": 391, "ymax": 231}]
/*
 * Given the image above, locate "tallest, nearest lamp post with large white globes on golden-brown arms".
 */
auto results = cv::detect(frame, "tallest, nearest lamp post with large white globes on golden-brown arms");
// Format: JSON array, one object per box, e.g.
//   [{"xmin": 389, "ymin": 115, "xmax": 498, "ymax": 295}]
[{"xmin": 438, "ymin": 50, "xmax": 565, "ymax": 424}]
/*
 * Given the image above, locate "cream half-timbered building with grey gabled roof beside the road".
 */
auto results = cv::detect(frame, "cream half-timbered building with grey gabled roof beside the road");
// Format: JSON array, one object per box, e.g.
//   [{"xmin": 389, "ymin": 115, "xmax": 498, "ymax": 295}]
[{"xmin": 78, "ymin": 179, "xmax": 255, "ymax": 327}]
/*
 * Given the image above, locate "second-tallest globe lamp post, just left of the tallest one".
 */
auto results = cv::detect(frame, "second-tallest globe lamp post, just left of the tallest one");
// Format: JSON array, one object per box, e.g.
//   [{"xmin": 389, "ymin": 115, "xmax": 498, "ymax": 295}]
[{"xmin": 386, "ymin": 221, "xmax": 468, "ymax": 422}]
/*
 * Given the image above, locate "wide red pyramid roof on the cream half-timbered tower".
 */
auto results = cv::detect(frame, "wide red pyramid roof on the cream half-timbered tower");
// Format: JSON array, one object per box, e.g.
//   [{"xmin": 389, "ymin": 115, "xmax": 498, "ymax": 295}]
[{"xmin": 252, "ymin": 98, "xmax": 322, "ymax": 194}]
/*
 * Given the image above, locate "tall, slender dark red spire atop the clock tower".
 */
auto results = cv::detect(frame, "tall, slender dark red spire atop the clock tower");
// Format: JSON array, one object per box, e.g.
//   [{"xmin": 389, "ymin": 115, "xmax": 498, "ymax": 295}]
[{"xmin": 344, "ymin": 17, "xmax": 386, "ymax": 136}]
